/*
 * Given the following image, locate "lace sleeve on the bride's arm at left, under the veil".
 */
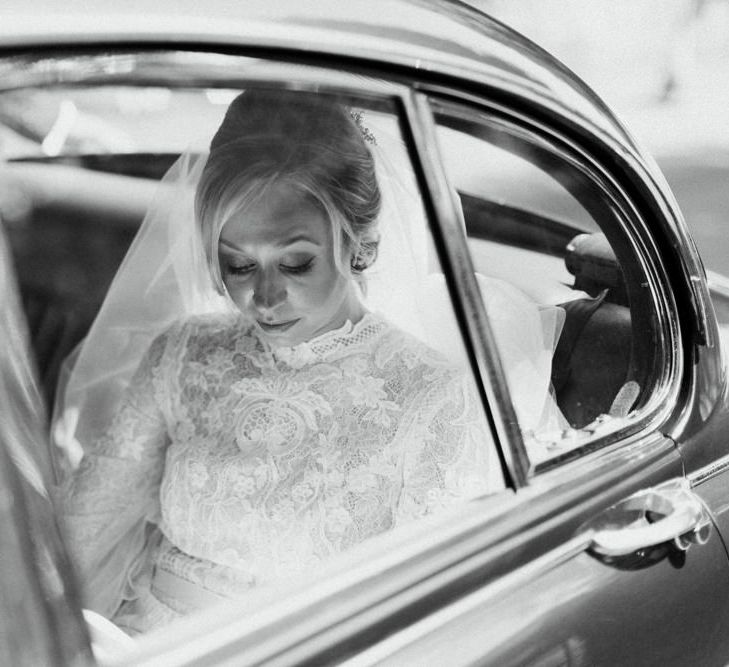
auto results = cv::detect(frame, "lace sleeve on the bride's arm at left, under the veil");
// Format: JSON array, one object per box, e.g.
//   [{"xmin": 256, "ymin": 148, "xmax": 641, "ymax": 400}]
[{"xmin": 60, "ymin": 333, "xmax": 175, "ymax": 616}]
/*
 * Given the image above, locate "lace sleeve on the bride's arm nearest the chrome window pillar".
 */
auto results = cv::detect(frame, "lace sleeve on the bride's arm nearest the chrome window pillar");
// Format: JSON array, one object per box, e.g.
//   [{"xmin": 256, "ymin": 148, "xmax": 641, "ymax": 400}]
[{"xmin": 396, "ymin": 373, "xmax": 504, "ymax": 523}]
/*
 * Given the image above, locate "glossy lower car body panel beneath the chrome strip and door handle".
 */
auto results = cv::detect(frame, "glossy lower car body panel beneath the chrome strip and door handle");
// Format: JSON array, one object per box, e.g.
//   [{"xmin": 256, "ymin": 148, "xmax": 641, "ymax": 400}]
[{"xmin": 358, "ymin": 543, "xmax": 727, "ymax": 666}]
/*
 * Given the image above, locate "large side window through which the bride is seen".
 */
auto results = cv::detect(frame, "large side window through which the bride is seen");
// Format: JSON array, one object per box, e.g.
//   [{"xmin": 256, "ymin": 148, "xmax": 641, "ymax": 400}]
[{"xmin": 0, "ymin": 82, "xmax": 505, "ymax": 648}]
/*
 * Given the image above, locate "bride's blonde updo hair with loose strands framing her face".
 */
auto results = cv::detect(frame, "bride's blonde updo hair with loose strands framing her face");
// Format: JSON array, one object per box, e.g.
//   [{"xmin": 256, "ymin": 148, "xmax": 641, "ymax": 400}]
[{"xmin": 195, "ymin": 89, "xmax": 381, "ymax": 293}]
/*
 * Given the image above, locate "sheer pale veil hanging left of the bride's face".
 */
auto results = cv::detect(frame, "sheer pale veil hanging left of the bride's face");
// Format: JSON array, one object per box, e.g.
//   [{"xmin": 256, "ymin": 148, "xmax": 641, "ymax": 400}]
[{"xmin": 53, "ymin": 149, "xmax": 228, "ymax": 472}]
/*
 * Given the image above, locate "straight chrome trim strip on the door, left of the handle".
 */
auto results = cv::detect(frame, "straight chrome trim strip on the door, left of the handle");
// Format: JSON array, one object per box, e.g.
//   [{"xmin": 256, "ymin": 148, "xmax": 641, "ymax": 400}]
[{"xmin": 340, "ymin": 531, "xmax": 592, "ymax": 667}]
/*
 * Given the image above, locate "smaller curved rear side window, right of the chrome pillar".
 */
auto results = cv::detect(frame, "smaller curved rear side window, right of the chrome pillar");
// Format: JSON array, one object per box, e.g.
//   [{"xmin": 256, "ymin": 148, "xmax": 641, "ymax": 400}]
[{"xmin": 433, "ymin": 101, "xmax": 660, "ymax": 465}]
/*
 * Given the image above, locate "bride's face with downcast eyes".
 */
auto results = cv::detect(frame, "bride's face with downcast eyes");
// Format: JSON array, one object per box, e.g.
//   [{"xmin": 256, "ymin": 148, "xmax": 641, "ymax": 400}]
[{"xmin": 218, "ymin": 184, "xmax": 363, "ymax": 346}]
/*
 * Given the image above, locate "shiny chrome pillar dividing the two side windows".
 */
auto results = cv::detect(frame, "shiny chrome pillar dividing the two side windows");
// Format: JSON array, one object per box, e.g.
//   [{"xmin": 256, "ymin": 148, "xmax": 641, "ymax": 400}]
[{"xmin": 405, "ymin": 92, "xmax": 530, "ymax": 488}]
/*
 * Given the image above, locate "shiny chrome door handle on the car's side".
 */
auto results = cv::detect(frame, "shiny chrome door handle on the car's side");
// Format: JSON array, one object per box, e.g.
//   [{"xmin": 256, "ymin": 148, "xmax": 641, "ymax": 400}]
[{"xmin": 589, "ymin": 479, "xmax": 711, "ymax": 556}]
